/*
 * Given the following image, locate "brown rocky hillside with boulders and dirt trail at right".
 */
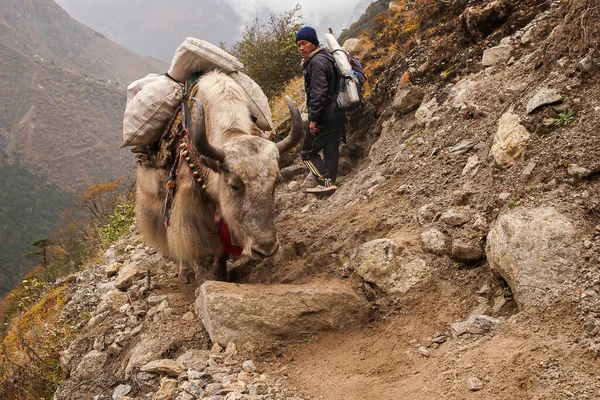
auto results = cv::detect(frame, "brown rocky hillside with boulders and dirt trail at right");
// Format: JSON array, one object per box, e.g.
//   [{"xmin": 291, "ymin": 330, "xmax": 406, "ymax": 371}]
[{"xmin": 1, "ymin": 0, "xmax": 600, "ymax": 400}]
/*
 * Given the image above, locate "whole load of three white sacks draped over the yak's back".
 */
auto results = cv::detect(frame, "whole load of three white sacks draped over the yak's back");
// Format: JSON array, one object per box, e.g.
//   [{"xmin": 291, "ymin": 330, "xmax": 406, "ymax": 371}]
[{"xmin": 121, "ymin": 37, "xmax": 273, "ymax": 147}]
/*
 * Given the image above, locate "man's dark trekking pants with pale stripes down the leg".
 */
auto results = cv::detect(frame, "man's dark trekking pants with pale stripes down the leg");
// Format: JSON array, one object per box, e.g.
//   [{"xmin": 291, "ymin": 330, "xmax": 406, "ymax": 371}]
[{"xmin": 301, "ymin": 123, "xmax": 345, "ymax": 187}]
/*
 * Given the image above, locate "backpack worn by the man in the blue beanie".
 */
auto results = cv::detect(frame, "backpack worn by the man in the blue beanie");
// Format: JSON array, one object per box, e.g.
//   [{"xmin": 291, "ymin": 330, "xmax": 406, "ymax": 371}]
[{"xmin": 333, "ymin": 49, "xmax": 367, "ymax": 111}]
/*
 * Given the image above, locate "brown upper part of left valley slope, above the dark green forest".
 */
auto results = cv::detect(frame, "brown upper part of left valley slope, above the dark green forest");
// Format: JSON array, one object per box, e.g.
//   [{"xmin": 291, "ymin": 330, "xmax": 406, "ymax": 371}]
[{"xmin": 0, "ymin": 0, "xmax": 167, "ymax": 191}]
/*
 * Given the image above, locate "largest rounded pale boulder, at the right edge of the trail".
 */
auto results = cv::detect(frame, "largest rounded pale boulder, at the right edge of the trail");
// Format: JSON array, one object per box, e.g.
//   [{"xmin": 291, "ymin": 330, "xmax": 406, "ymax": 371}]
[{"xmin": 485, "ymin": 208, "xmax": 580, "ymax": 309}]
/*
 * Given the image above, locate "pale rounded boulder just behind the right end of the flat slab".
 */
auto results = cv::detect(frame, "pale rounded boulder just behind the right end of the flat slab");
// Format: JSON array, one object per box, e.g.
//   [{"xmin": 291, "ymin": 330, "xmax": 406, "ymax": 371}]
[{"xmin": 350, "ymin": 239, "xmax": 431, "ymax": 295}]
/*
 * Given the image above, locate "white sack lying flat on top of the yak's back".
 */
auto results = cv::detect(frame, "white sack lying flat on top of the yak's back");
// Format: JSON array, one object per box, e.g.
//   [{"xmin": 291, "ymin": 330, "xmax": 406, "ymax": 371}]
[{"xmin": 168, "ymin": 37, "xmax": 244, "ymax": 82}]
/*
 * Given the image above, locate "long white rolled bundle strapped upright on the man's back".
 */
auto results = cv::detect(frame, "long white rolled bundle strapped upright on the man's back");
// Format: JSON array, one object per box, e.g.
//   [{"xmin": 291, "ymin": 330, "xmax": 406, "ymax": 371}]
[{"xmin": 325, "ymin": 33, "xmax": 361, "ymax": 110}]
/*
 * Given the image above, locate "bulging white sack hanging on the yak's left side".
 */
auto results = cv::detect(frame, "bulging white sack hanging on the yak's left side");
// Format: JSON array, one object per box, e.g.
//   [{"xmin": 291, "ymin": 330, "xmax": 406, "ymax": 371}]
[{"xmin": 121, "ymin": 74, "xmax": 182, "ymax": 148}]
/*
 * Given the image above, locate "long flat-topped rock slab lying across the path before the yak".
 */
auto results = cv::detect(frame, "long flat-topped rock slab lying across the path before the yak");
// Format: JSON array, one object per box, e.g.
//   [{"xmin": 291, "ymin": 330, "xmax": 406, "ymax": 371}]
[{"xmin": 195, "ymin": 281, "xmax": 369, "ymax": 345}]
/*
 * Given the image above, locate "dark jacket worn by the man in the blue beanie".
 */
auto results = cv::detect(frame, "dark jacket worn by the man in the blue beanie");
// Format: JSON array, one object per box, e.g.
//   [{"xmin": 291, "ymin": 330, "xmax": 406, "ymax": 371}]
[{"xmin": 304, "ymin": 49, "xmax": 345, "ymax": 126}]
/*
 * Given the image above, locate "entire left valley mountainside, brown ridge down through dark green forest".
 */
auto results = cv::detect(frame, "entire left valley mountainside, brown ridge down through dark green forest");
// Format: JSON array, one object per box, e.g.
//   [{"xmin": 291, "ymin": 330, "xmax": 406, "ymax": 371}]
[{"xmin": 0, "ymin": 0, "xmax": 168, "ymax": 295}]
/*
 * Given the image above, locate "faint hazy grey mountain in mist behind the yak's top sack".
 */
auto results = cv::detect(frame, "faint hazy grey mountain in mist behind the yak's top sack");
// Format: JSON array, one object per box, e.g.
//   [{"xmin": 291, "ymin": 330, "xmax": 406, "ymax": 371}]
[{"xmin": 57, "ymin": 0, "xmax": 242, "ymax": 62}]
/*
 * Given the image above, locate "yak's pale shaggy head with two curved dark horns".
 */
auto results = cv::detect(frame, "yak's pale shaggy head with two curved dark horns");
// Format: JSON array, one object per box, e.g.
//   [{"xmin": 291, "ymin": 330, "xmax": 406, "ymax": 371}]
[{"xmin": 193, "ymin": 97, "xmax": 302, "ymax": 258}]
